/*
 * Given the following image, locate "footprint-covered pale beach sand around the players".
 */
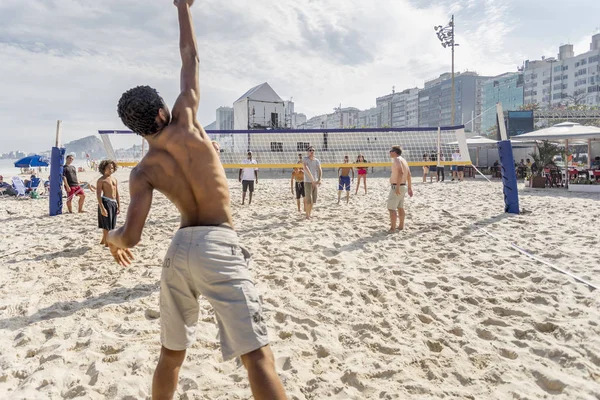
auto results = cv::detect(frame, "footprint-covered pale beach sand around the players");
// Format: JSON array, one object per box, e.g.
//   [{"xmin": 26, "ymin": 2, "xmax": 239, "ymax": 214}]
[{"xmin": 0, "ymin": 171, "xmax": 600, "ymax": 399}]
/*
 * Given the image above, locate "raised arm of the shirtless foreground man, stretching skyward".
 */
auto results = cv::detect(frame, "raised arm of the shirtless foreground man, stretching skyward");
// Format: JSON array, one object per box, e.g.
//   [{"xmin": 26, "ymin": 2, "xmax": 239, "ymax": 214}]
[{"xmin": 173, "ymin": 0, "xmax": 200, "ymax": 122}]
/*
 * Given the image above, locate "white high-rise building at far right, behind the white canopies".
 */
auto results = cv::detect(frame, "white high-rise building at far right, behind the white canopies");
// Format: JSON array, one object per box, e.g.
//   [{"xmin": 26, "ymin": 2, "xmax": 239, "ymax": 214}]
[{"xmin": 523, "ymin": 34, "xmax": 600, "ymax": 108}]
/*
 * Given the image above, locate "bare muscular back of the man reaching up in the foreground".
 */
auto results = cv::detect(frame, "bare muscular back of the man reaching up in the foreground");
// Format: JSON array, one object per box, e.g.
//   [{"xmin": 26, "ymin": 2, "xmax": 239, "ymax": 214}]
[{"xmin": 130, "ymin": 121, "xmax": 233, "ymax": 228}]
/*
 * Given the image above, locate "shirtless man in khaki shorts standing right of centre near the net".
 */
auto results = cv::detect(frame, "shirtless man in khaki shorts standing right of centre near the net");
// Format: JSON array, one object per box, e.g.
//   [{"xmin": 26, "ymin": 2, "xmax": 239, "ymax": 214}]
[{"xmin": 387, "ymin": 146, "xmax": 413, "ymax": 233}]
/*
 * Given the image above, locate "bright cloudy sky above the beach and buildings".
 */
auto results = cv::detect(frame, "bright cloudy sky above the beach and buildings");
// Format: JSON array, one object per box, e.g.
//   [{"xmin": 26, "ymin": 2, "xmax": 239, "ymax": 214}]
[{"xmin": 0, "ymin": 0, "xmax": 600, "ymax": 153}]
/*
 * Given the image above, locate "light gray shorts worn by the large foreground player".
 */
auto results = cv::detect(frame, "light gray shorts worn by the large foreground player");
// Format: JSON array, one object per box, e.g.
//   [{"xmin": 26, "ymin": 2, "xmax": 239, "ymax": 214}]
[{"xmin": 160, "ymin": 226, "xmax": 269, "ymax": 360}]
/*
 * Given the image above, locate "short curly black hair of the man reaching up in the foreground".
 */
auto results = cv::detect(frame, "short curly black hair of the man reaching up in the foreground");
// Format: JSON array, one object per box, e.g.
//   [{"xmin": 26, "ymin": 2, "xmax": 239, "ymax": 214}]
[{"xmin": 117, "ymin": 86, "xmax": 165, "ymax": 136}]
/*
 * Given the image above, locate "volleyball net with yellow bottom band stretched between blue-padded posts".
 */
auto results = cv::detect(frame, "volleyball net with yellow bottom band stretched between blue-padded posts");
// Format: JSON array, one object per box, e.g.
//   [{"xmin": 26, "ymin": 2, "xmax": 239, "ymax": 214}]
[{"xmin": 98, "ymin": 126, "xmax": 471, "ymax": 169}]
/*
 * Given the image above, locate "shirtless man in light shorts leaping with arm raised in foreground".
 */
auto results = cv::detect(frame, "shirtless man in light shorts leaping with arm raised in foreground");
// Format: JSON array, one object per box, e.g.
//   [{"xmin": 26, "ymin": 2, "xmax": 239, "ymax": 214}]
[{"xmin": 108, "ymin": 0, "xmax": 286, "ymax": 400}]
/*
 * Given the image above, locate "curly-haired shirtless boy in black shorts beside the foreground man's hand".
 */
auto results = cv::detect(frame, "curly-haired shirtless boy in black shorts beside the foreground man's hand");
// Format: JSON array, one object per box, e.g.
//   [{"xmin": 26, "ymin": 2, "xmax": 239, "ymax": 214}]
[{"xmin": 96, "ymin": 160, "xmax": 121, "ymax": 247}]
